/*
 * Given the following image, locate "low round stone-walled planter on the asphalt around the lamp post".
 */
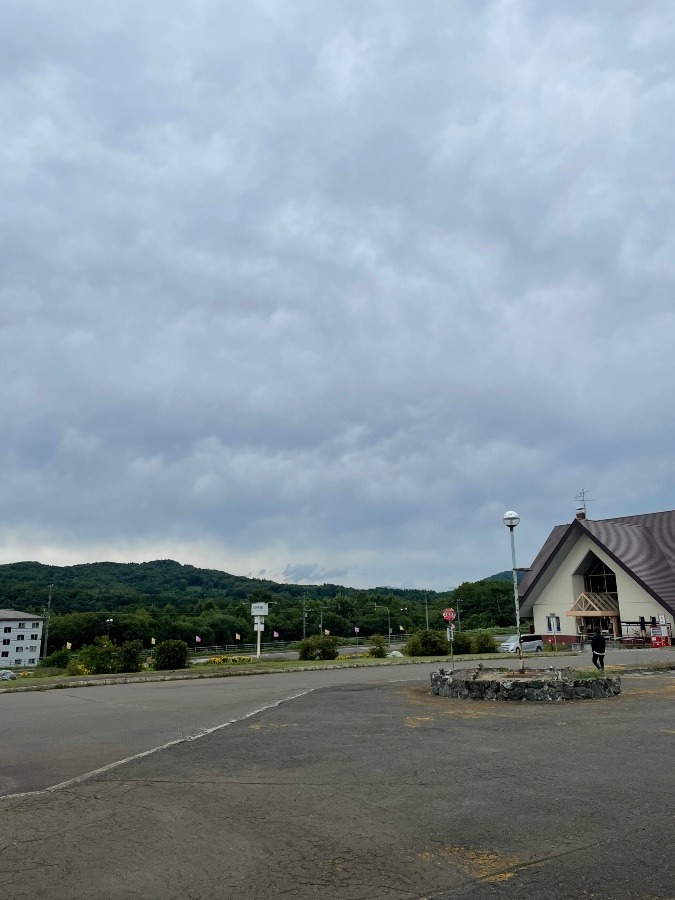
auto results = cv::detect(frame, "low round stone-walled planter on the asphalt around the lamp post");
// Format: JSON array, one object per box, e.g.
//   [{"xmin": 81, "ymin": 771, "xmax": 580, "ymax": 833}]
[{"xmin": 431, "ymin": 670, "xmax": 621, "ymax": 703}]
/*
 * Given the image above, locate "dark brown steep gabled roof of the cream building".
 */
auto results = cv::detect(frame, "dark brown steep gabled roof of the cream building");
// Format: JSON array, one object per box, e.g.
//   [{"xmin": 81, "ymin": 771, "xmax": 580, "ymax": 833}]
[{"xmin": 518, "ymin": 510, "xmax": 675, "ymax": 614}]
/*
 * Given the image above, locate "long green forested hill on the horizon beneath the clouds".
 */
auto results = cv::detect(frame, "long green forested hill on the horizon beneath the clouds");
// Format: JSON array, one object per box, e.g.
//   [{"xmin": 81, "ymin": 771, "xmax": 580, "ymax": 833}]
[{"xmin": 0, "ymin": 559, "xmax": 447, "ymax": 613}]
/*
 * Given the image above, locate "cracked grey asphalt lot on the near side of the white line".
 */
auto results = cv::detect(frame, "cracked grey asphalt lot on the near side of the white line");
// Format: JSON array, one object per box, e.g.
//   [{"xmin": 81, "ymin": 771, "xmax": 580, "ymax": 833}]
[{"xmin": 0, "ymin": 667, "xmax": 675, "ymax": 900}]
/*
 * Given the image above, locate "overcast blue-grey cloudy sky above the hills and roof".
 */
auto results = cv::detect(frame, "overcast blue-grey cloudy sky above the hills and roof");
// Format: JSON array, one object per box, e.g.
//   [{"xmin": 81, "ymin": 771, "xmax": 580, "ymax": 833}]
[{"xmin": 0, "ymin": 0, "xmax": 675, "ymax": 590}]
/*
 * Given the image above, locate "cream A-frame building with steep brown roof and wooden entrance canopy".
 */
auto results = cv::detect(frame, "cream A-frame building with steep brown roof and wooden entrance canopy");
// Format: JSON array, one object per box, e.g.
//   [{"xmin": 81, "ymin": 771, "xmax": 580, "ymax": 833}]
[{"xmin": 518, "ymin": 510, "xmax": 675, "ymax": 643}]
